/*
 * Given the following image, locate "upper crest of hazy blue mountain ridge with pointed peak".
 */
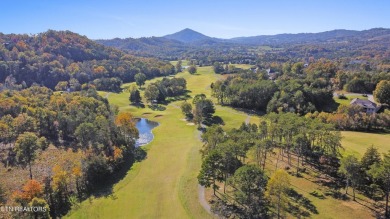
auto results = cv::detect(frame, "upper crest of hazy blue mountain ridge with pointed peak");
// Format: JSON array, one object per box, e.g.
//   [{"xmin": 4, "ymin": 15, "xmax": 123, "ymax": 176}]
[{"xmin": 97, "ymin": 28, "xmax": 390, "ymax": 46}]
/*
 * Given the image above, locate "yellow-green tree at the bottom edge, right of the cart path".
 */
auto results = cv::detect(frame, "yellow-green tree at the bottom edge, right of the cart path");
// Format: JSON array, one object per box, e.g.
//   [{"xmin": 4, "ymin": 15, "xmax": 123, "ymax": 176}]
[{"xmin": 266, "ymin": 169, "xmax": 290, "ymax": 219}]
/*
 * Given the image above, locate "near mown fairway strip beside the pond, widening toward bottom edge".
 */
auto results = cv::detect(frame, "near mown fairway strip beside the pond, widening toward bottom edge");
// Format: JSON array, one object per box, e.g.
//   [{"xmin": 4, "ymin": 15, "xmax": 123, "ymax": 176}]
[{"xmin": 69, "ymin": 105, "xmax": 213, "ymax": 218}]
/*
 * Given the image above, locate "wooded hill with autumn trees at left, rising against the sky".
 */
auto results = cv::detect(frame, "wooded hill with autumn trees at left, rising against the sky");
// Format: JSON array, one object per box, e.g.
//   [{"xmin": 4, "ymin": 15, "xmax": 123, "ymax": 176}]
[{"xmin": 0, "ymin": 30, "xmax": 175, "ymax": 91}]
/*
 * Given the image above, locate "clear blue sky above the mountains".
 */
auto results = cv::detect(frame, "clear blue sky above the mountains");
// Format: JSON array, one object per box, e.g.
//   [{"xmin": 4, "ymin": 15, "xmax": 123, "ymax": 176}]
[{"xmin": 0, "ymin": 0, "xmax": 390, "ymax": 39}]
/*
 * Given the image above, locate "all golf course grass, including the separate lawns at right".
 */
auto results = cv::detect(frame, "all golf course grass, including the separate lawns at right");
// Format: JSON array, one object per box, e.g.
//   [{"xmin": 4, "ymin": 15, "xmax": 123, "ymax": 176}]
[{"xmin": 67, "ymin": 64, "xmax": 390, "ymax": 218}]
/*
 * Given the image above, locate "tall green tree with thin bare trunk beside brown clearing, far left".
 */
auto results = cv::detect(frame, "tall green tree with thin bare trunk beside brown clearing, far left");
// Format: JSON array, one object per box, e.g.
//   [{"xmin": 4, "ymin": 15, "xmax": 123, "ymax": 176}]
[{"xmin": 14, "ymin": 132, "xmax": 40, "ymax": 179}]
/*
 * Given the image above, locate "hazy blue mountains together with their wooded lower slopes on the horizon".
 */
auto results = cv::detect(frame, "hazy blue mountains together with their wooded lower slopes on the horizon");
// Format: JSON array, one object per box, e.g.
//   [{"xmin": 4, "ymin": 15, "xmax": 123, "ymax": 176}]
[{"xmin": 96, "ymin": 28, "xmax": 390, "ymax": 60}]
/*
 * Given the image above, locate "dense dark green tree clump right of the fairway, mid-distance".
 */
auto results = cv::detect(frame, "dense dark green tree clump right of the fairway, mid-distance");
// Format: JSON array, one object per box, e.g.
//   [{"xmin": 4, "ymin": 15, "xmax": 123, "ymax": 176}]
[{"xmin": 211, "ymin": 71, "xmax": 335, "ymax": 115}]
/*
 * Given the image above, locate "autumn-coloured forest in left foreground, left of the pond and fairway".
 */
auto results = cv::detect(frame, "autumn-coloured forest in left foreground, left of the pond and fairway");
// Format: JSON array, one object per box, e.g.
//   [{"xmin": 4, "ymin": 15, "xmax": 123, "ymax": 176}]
[{"xmin": 0, "ymin": 86, "xmax": 138, "ymax": 218}]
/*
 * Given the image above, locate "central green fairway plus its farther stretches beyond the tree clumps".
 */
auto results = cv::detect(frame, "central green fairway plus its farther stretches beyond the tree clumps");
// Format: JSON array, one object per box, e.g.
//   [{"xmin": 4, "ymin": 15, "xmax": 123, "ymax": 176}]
[{"xmin": 68, "ymin": 67, "xmax": 250, "ymax": 218}]
